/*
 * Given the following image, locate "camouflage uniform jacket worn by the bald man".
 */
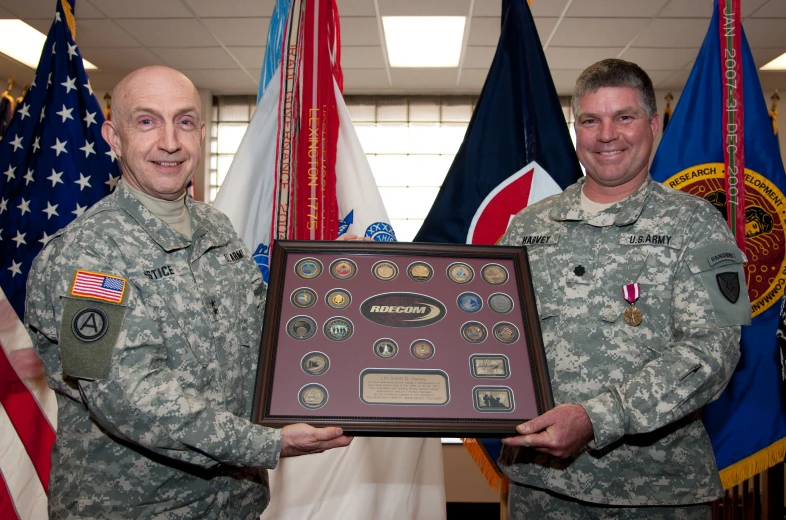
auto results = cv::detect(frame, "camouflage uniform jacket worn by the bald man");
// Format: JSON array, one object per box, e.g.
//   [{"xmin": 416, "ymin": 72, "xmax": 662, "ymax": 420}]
[{"xmin": 25, "ymin": 183, "xmax": 281, "ymax": 520}]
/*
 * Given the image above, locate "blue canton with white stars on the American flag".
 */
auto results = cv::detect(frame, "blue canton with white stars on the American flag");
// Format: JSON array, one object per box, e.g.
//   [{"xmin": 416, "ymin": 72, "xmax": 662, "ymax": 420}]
[{"xmin": 0, "ymin": 0, "xmax": 120, "ymax": 319}]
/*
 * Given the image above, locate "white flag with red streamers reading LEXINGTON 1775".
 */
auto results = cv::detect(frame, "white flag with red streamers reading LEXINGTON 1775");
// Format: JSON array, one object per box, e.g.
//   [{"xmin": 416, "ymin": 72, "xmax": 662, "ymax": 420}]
[{"xmin": 214, "ymin": 0, "xmax": 438, "ymax": 520}]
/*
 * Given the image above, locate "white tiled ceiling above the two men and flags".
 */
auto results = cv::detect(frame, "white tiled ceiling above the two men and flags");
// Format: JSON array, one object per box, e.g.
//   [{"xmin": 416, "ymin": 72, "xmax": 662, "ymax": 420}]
[{"xmin": 0, "ymin": 0, "xmax": 786, "ymax": 94}]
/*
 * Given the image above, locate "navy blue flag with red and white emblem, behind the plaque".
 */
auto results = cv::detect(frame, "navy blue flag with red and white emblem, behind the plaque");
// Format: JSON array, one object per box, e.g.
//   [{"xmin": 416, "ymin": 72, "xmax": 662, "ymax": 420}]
[{"xmin": 415, "ymin": 0, "xmax": 582, "ymax": 489}]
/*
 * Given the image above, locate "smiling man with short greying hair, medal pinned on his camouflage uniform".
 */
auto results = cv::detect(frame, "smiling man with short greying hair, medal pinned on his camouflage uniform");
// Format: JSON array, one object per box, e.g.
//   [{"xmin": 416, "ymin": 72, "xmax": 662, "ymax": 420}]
[{"xmin": 500, "ymin": 60, "xmax": 750, "ymax": 519}]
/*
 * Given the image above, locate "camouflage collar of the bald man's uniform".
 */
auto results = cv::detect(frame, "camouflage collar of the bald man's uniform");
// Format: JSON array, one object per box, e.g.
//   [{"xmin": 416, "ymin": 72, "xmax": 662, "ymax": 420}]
[{"xmin": 115, "ymin": 180, "xmax": 226, "ymax": 253}]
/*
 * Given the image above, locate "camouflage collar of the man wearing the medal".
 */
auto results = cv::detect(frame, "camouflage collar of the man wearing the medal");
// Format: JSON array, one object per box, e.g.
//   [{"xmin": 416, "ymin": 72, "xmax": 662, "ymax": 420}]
[{"xmin": 549, "ymin": 174, "xmax": 654, "ymax": 227}]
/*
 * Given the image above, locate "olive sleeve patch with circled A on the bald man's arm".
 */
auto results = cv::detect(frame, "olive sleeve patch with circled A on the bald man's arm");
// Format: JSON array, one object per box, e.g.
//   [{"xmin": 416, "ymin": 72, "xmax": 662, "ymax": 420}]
[{"xmin": 60, "ymin": 297, "xmax": 126, "ymax": 379}]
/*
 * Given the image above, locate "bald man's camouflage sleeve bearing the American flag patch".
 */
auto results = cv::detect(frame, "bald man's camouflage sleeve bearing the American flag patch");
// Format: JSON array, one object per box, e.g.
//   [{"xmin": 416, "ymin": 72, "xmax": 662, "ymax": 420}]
[{"xmin": 26, "ymin": 234, "xmax": 281, "ymax": 468}]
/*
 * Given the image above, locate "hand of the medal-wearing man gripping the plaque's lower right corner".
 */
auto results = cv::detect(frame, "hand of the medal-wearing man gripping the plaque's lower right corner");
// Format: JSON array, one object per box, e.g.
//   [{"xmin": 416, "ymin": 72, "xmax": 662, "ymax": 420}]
[{"xmin": 502, "ymin": 404, "xmax": 593, "ymax": 458}]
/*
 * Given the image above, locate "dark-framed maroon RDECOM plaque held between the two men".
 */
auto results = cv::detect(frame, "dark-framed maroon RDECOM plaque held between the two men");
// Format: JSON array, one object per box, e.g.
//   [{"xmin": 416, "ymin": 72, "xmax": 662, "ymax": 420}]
[{"xmin": 252, "ymin": 241, "xmax": 553, "ymax": 437}]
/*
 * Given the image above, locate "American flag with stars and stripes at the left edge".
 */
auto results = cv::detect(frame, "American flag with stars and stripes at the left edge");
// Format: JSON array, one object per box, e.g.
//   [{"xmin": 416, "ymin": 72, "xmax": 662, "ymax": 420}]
[{"xmin": 0, "ymin": 0, "xmax": 120, "ymax": 520}]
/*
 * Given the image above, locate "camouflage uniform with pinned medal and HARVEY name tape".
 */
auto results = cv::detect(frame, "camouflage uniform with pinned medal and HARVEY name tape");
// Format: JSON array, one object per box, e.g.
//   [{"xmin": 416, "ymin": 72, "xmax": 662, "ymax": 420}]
[{"xmin": 500, "ymin": 177, "xmax": 750, "ymax": 510}]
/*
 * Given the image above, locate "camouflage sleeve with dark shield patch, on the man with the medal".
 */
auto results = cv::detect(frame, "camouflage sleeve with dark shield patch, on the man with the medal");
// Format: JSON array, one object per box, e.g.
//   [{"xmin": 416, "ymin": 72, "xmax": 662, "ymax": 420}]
[{"xmin": 580, "ymin": 205, "xmax": 751, "ymax": 449}]
